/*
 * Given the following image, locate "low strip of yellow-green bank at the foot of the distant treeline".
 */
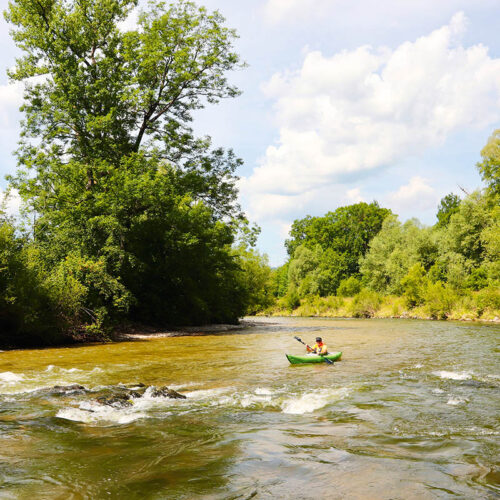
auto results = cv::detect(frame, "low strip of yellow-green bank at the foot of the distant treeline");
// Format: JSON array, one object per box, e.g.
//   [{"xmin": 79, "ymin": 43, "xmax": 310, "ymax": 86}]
[{"xmin": 258, "ymin": 292, "xmax": 500, "ymax": 323}]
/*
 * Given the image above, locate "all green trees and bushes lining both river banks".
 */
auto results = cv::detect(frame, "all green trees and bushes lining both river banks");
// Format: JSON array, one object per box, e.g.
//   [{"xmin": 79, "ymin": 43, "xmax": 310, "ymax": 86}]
[{"xmin": 0, "ymin": 0, "xmax": 500, "ymax": 345}]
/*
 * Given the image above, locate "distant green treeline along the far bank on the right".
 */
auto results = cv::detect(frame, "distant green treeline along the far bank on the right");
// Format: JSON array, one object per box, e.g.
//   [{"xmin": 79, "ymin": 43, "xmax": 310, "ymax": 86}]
[{"xmin": 263, "ymin": 130, "xmax": 500, "ymax": 319}]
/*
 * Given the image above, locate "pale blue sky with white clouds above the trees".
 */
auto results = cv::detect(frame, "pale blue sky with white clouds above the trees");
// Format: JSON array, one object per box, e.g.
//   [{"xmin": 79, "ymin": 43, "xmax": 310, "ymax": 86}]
[{"xmin": 0, "ymin": 0, "xmax": 500, "ymax": 265}]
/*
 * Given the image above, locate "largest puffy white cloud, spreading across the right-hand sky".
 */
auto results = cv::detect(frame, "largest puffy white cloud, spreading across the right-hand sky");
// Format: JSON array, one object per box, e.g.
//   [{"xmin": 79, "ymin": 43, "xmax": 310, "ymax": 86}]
[{"xmin": 240, "ymin": 13, "xmax": 500, "ymax": 219}]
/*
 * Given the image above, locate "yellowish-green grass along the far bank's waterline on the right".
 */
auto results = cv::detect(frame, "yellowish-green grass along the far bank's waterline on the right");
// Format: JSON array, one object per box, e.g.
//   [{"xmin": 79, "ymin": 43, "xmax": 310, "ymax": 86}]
[{"xmin": 259, "ymin": 284, "xmax": 500, "ymax": 321}]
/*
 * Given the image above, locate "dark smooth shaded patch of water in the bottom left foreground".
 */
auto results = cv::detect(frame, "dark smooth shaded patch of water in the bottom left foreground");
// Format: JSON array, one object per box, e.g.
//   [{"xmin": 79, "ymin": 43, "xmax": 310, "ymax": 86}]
[{"xmin": 0, "ymin": 416, "xmax": 239, "ymax": 499}]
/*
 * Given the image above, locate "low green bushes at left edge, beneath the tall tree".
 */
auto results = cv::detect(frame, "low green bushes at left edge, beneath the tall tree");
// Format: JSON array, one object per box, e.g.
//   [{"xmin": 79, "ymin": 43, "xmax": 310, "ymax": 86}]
[{"xmin": 0, "ymin": 222, "xmax": 131, "ymax": 346}]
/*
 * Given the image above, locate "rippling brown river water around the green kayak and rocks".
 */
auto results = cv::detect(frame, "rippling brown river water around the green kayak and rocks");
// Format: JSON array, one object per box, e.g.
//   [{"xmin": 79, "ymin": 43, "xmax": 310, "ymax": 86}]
[{"xmin": 0, "ymin": 318, "xmax": 500, "ymax": 499}]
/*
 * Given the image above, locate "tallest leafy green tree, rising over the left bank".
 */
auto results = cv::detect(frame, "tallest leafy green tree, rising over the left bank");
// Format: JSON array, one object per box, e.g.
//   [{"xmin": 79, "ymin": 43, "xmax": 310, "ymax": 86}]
[{"xmin": 5, "ymin": 0, "xmax": 249, "ymax": 323}]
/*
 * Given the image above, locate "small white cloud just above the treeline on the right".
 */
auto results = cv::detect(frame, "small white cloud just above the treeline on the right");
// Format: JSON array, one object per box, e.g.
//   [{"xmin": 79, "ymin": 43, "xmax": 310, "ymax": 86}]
[{"xmin": 387, "ymin": 176, "xmax": 440, "ymax": 213}]
